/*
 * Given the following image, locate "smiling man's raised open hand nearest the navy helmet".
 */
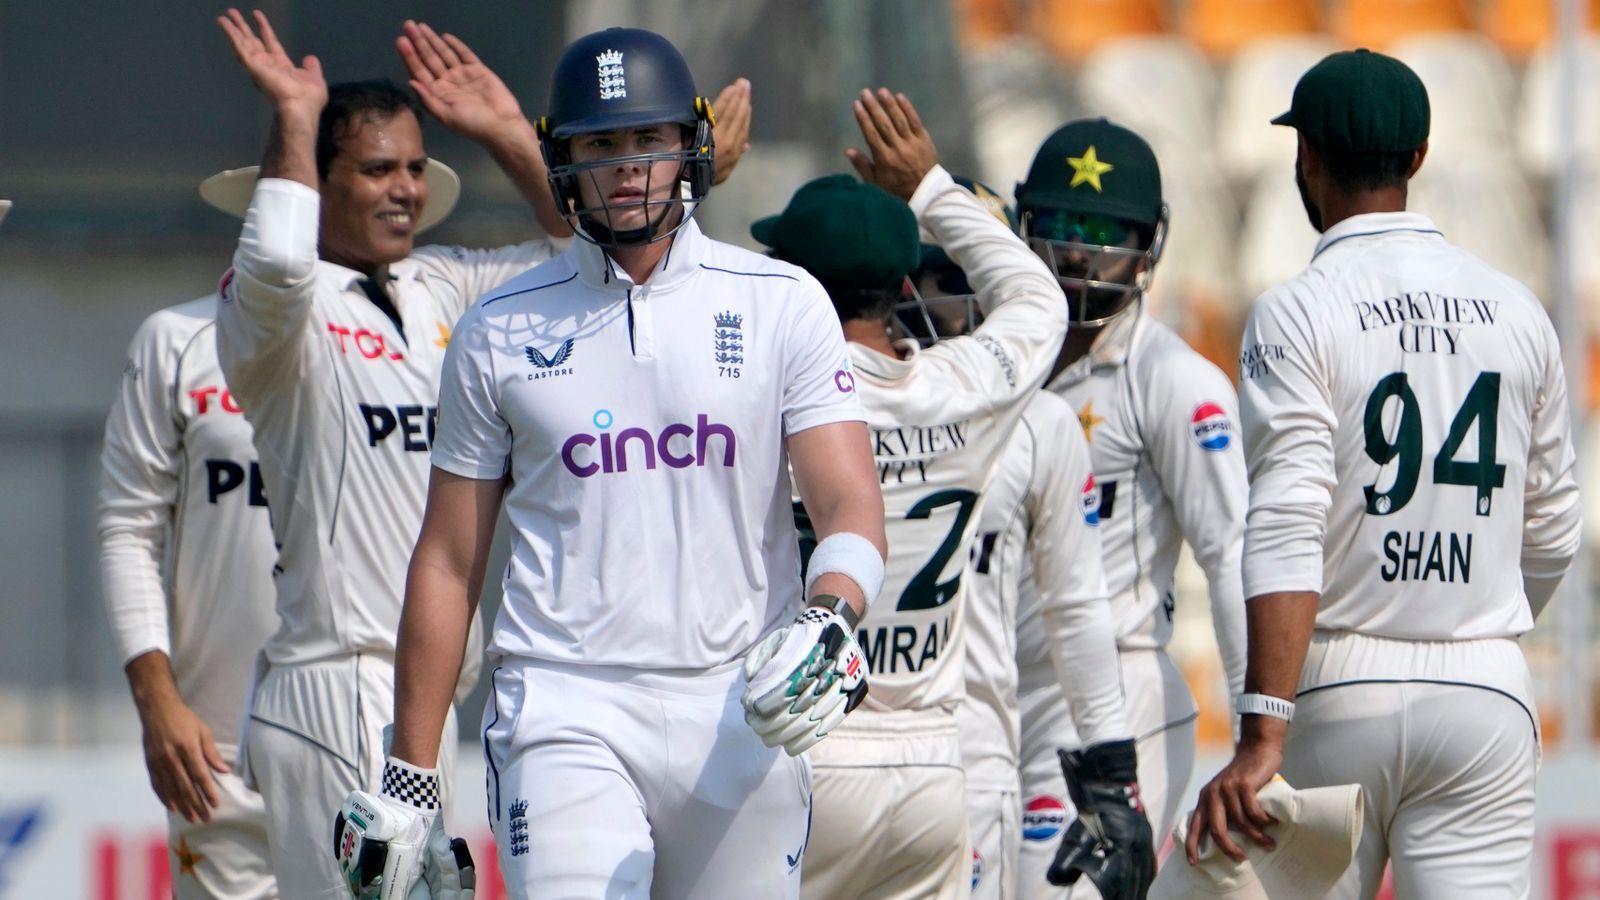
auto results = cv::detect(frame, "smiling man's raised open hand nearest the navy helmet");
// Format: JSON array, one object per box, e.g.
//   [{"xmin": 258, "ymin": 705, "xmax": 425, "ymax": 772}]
[{"xmin": 395, "ymin": 19, "xmax": 526, "ymax": 143}]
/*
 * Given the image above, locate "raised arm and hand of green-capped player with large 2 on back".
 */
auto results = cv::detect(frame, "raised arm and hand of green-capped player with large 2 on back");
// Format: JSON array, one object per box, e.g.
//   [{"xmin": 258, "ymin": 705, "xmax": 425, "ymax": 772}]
[{"xmin": 846, "ymin": 88, "xmax": 1067, "ymax": 405}]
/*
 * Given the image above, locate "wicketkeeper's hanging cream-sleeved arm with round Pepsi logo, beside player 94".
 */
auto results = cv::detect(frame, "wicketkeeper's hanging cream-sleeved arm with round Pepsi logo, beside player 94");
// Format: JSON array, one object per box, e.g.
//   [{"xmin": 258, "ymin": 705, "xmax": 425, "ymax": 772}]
[{"xmin": 1142, "ymin": 354, "xmax": 1250, "ymax": 695}]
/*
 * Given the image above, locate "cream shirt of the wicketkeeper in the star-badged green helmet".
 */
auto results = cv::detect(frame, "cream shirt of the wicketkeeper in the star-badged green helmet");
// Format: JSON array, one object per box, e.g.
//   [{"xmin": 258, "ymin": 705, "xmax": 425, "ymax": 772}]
[{"xmin": 1049, "ymin": 306, "xmax": 1248, "ymax": 693}]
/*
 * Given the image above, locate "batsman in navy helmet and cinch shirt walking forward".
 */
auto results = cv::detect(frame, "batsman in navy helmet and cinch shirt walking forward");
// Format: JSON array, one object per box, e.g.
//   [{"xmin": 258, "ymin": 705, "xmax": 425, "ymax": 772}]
[{"xmin": 346, "ymin": 29, "xmax": 883, "ymax": 898}]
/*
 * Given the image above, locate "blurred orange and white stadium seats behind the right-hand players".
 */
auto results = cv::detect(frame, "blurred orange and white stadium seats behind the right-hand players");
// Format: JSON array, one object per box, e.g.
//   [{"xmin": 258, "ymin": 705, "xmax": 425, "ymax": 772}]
[{"xmin": 934, "ymin": 0, "xmax": 1600, "ymax": 746}]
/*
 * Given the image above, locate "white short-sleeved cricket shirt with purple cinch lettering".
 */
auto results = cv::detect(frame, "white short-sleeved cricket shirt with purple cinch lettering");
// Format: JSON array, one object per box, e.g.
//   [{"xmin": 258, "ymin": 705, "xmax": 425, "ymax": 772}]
[{"xmin": 434, "ymin": 219, "xmax": 862, "ymax": 669}]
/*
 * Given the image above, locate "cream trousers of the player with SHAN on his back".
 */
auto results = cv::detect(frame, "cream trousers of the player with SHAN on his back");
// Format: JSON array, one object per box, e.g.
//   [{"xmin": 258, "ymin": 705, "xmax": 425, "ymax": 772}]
[{"xmin": 1283, "ymin": 631, "xmax": 1539, "ymax": 900}]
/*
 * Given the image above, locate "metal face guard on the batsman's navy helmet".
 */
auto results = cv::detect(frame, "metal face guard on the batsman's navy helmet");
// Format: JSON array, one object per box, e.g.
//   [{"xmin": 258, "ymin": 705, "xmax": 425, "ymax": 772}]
[{"xmin": 539, "ymin": 113, "xmax": 714, "ymax": 250}]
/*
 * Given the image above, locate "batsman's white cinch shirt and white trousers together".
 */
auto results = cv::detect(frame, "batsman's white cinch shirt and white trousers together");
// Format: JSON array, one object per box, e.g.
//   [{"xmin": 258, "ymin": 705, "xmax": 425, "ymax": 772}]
[{"xmin": 434, "ymin": 212, "xmax": 862, "ymax": 897}]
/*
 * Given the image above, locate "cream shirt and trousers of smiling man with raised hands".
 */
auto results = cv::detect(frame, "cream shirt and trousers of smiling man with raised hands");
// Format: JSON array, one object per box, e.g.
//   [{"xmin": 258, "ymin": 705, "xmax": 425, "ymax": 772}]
[{"xmin": 218, "ymin": 178, "xmax": 549, "ymax": 898}]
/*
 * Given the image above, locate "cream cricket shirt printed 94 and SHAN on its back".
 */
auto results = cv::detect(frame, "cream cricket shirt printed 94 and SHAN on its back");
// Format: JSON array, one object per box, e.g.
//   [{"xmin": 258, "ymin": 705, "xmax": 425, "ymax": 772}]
[{"xmin": 1240, "ymin": 213, "xmax": 1581, "ymax": 641}]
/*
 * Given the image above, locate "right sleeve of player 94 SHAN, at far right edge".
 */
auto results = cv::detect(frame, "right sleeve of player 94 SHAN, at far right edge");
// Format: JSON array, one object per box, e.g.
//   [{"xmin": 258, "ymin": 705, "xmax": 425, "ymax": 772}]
[{"xmin": 1522, "ymin": 310, "xmax": 1582, "ymax": 618}]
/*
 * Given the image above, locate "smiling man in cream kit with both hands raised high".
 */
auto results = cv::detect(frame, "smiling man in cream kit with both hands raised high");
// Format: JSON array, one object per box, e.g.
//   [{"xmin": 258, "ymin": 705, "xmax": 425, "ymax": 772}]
[{"xmin": 216, "ymin": 11, "xmax": 576, "ymax": 898}]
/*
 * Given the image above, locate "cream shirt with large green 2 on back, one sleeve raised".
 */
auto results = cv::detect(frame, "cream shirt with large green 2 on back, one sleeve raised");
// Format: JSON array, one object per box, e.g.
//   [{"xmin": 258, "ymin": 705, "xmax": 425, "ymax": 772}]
[{"xmin": 821, "ymin": 167, "xmax": 1067, "ymax": 720}]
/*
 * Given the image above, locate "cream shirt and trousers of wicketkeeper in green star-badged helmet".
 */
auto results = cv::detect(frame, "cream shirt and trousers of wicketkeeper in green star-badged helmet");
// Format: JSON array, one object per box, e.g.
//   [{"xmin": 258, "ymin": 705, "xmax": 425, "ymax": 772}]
[{"xmin": 1018, "ymin": 306, "xmax": 1248, "ymax": 897}]
